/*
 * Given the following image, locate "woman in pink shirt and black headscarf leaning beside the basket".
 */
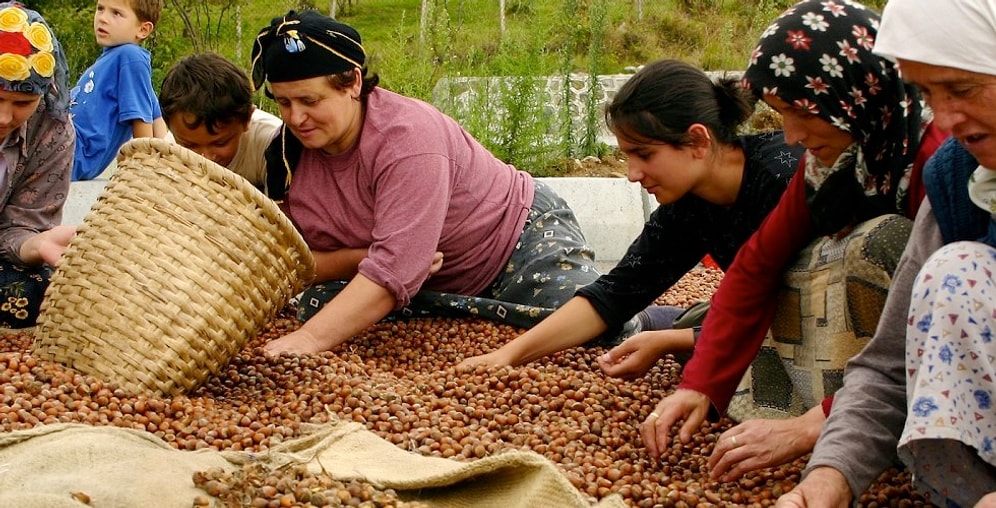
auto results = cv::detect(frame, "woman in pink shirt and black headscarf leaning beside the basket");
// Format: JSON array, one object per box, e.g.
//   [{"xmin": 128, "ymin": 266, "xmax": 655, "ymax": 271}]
[{"xmin": 252, "ymin": 11, "xmax": 598, "ymax": 354}]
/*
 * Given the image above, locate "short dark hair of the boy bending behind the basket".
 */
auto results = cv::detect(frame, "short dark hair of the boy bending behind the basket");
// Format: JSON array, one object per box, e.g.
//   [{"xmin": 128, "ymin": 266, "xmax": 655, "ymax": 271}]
[{"xmin": 159, "ymin": 52, "xmax": 253, "ymax": 134}]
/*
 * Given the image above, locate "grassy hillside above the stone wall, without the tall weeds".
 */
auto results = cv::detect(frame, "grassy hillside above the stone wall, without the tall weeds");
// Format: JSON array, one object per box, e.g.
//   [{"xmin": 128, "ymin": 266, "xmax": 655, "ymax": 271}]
[{"xmin": 152, "ymin": 0, "xmax": 836, "ymax": 99}]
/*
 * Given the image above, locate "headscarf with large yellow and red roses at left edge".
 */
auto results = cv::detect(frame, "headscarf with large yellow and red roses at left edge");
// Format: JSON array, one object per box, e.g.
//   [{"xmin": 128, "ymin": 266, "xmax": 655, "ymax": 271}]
[{"xmin": 0, "ymin": 2, "xmax": 69, "ymax": 119}]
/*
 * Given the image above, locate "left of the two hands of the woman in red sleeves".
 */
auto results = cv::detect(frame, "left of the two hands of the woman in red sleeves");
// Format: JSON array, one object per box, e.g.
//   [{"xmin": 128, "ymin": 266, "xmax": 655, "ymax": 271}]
[{"xmin": 640, "ymin": 389, "xmax": 710, "ymax": 458}]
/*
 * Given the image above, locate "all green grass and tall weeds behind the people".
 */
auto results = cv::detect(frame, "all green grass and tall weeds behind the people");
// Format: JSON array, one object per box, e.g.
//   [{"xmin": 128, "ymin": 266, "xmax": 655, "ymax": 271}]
[{"xmin": 33, "ymin": 0, "xmax": 885, "ymax": 174}]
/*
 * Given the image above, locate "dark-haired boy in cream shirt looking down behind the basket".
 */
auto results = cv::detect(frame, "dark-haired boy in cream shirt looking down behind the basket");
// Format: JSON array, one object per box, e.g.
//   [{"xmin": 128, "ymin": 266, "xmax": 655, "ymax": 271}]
[{"xmin": 159, "ymin": 53, "xmax": 282, "ymax": 192}]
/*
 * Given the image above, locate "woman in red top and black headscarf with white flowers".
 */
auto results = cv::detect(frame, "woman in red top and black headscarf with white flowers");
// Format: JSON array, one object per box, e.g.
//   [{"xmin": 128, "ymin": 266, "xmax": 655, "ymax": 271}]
[{"xmin": 641, "ymin": 0, "xmax": 945, "ymax": 481}]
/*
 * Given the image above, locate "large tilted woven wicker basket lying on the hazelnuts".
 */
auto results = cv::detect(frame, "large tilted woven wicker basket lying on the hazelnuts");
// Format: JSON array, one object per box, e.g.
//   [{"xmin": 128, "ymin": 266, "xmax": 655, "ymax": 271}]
[{"xmin": 34, "ymin": 138, "xmax": 315, "ymax": 395}]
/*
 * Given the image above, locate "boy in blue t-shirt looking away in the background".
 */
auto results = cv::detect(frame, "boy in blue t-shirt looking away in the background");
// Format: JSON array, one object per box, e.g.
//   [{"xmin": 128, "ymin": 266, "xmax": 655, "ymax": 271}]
[{"xmin": 70, "ymin": 0, "xmax": 166, "ymax": 180}]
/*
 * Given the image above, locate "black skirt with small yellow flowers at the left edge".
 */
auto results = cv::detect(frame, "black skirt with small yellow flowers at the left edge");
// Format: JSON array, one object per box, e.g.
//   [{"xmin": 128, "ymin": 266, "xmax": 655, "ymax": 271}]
[{"xmin": 0, "ymin": 261, "xmax": 52, "ymax": 328}]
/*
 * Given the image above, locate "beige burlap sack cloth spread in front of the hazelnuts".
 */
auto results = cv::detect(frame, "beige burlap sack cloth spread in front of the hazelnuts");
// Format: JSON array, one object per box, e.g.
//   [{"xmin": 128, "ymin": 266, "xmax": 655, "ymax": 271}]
[{"xmin": 0, "ymin": 422, "xmax": 626, "ymax": 508}]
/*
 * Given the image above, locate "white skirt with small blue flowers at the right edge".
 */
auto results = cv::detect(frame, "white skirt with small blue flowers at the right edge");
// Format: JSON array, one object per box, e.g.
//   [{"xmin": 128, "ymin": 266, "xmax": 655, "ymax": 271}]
[{"xmin": 899, "ymin": 242, "xmax": 996, "ymax": 506}]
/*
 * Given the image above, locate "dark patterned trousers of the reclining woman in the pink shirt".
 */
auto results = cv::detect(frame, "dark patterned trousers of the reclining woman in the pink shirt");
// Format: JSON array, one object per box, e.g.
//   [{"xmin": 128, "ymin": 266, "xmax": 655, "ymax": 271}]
[{"xmin": 298, "ymin": 180, "xmax": 599, "ymax": 328}]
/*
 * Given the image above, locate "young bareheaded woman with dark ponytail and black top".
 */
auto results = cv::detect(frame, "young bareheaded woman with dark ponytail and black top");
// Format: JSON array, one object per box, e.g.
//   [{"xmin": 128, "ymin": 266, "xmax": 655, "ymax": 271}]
[{"xmin": 460, "ymin": 60, "xmax": 802, "ymax": 377}]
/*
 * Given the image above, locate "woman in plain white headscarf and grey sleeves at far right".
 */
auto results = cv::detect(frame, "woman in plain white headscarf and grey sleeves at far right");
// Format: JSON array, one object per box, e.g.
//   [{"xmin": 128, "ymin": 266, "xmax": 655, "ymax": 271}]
[{"xmin": 777, "ymin": 0, "xmax": 996, "ymax": 508}]
